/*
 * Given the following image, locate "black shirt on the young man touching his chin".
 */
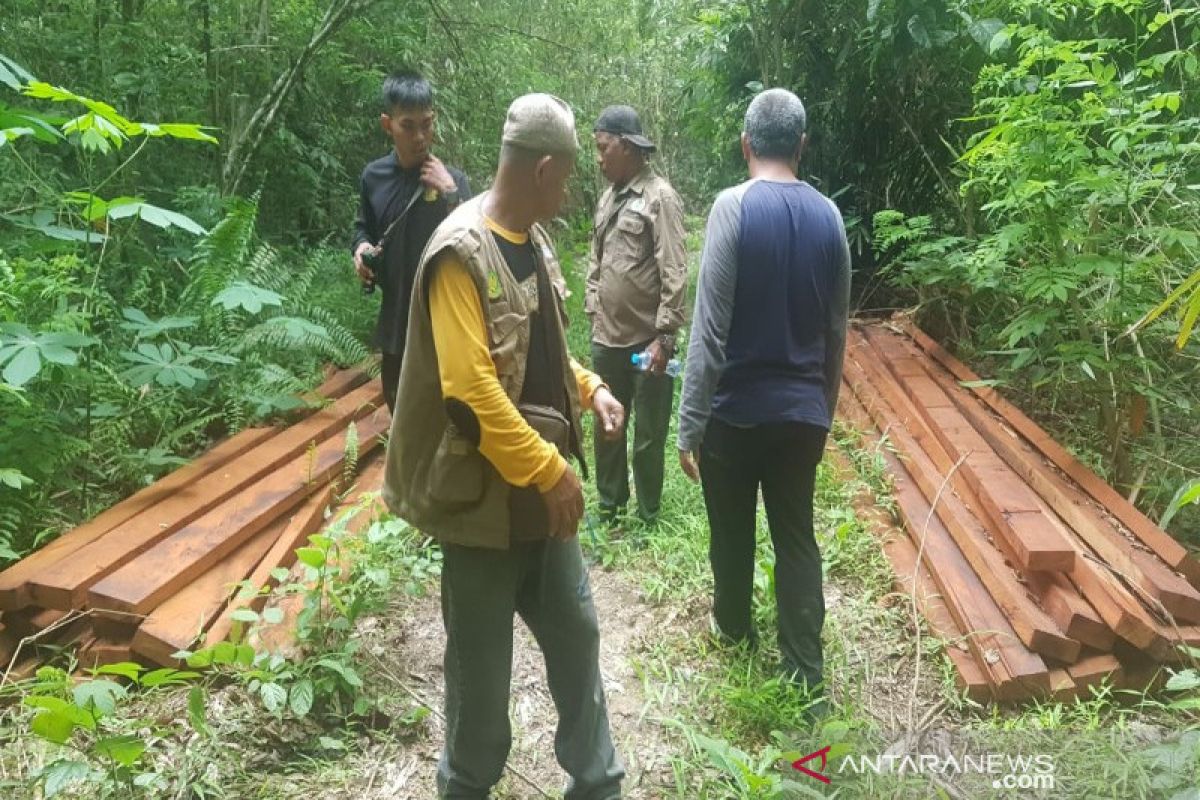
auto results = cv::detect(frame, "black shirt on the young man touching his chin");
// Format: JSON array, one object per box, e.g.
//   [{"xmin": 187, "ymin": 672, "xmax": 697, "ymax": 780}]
[{"xmin": 350, "ymin": 152, "xmax": 470, "ymax": 355}]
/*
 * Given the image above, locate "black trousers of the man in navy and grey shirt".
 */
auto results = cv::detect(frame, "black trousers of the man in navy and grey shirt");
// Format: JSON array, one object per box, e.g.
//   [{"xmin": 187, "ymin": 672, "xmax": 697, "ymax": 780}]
[{"xmin": 700, "ymin": 419, "xmax": 827, "ymax": 687}]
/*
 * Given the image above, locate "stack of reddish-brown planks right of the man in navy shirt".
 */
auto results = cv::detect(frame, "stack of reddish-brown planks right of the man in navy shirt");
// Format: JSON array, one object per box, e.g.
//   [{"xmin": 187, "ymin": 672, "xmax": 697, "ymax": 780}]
[{"xmin": 839, "ymin": 318, "xmax": 1200, "ymax": 702}]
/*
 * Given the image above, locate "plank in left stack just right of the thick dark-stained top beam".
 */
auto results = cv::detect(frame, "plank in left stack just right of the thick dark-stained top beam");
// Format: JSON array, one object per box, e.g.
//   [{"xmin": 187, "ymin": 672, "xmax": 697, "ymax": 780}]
[{"xmin": 132, "ymin": 513, "xmax": 292, "ymax": 667}]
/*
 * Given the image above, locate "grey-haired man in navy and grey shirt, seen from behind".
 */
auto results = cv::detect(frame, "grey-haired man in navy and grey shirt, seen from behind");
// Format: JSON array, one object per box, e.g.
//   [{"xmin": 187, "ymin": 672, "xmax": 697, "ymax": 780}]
[{"xmin": 678, "ymin": 89, "xmax": 850, "ymax": 710}]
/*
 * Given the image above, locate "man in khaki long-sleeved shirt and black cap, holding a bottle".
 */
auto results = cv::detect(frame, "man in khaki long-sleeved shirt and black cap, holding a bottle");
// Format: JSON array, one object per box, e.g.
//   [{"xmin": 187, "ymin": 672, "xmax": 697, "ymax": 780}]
[{"xmin": 584, "ymin": 106, "xmax": 688, "ymax": 532}]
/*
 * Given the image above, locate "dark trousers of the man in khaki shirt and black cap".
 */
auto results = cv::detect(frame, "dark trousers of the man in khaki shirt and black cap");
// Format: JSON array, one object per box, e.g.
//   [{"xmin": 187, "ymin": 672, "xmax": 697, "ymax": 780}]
[{"xmin": 592, "ymin": 342, "xmax": 674, "ymax": 521}]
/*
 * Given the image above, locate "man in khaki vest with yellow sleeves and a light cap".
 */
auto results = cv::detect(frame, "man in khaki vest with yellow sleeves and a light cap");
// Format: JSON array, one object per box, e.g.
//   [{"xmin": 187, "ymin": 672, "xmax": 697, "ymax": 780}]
[{"xmin": 384, "ymin": 95, "xmax": 625, "ymax": 800}]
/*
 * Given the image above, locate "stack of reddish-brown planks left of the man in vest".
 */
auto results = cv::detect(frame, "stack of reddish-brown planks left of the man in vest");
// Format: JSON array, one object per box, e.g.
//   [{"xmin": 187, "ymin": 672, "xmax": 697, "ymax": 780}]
[{"xmin": 0, "ymin": 369, "xmax": 390, "ymax": 678}]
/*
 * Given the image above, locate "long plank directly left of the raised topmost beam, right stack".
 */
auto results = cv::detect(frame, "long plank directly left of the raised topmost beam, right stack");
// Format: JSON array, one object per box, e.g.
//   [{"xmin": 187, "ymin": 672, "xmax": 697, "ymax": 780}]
[{"xmin": 844, "ymin": 354, "xmax": 1081, "ymax": 663}]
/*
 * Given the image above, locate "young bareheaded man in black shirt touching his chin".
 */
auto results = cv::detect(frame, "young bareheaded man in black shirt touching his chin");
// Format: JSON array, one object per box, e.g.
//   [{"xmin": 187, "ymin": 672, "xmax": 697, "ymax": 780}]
[{"xmin": 350, "ymin": 72, "xmax": 470, "ymax": 409}]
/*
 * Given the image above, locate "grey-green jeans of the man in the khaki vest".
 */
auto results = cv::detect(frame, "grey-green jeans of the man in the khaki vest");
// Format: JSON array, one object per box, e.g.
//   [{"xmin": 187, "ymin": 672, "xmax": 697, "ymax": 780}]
[{"xmin": 438, "ymin": 539, "xmax": 625, "ymax": 800}]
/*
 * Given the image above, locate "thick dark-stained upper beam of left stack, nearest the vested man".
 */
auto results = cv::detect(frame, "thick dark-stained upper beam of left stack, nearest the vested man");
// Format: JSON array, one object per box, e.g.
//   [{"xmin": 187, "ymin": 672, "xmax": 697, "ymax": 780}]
[{"xmin": 88, "ymin": 410, "xmax": 391, "ymax": 627}]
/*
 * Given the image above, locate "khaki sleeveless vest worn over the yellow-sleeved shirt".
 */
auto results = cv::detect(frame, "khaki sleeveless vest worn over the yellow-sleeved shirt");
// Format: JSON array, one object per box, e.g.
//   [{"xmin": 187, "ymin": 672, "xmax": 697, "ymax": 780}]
[{"xmin": 383, "ymin": 193, "xmax": 582, "ymax": 549}]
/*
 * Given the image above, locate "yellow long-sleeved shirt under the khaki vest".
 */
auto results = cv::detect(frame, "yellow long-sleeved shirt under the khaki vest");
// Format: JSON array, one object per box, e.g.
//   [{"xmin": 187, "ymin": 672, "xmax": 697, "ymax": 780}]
[{"xmin": 430, "ymin": 219, "xmax": 604, "ymax": 492}]
